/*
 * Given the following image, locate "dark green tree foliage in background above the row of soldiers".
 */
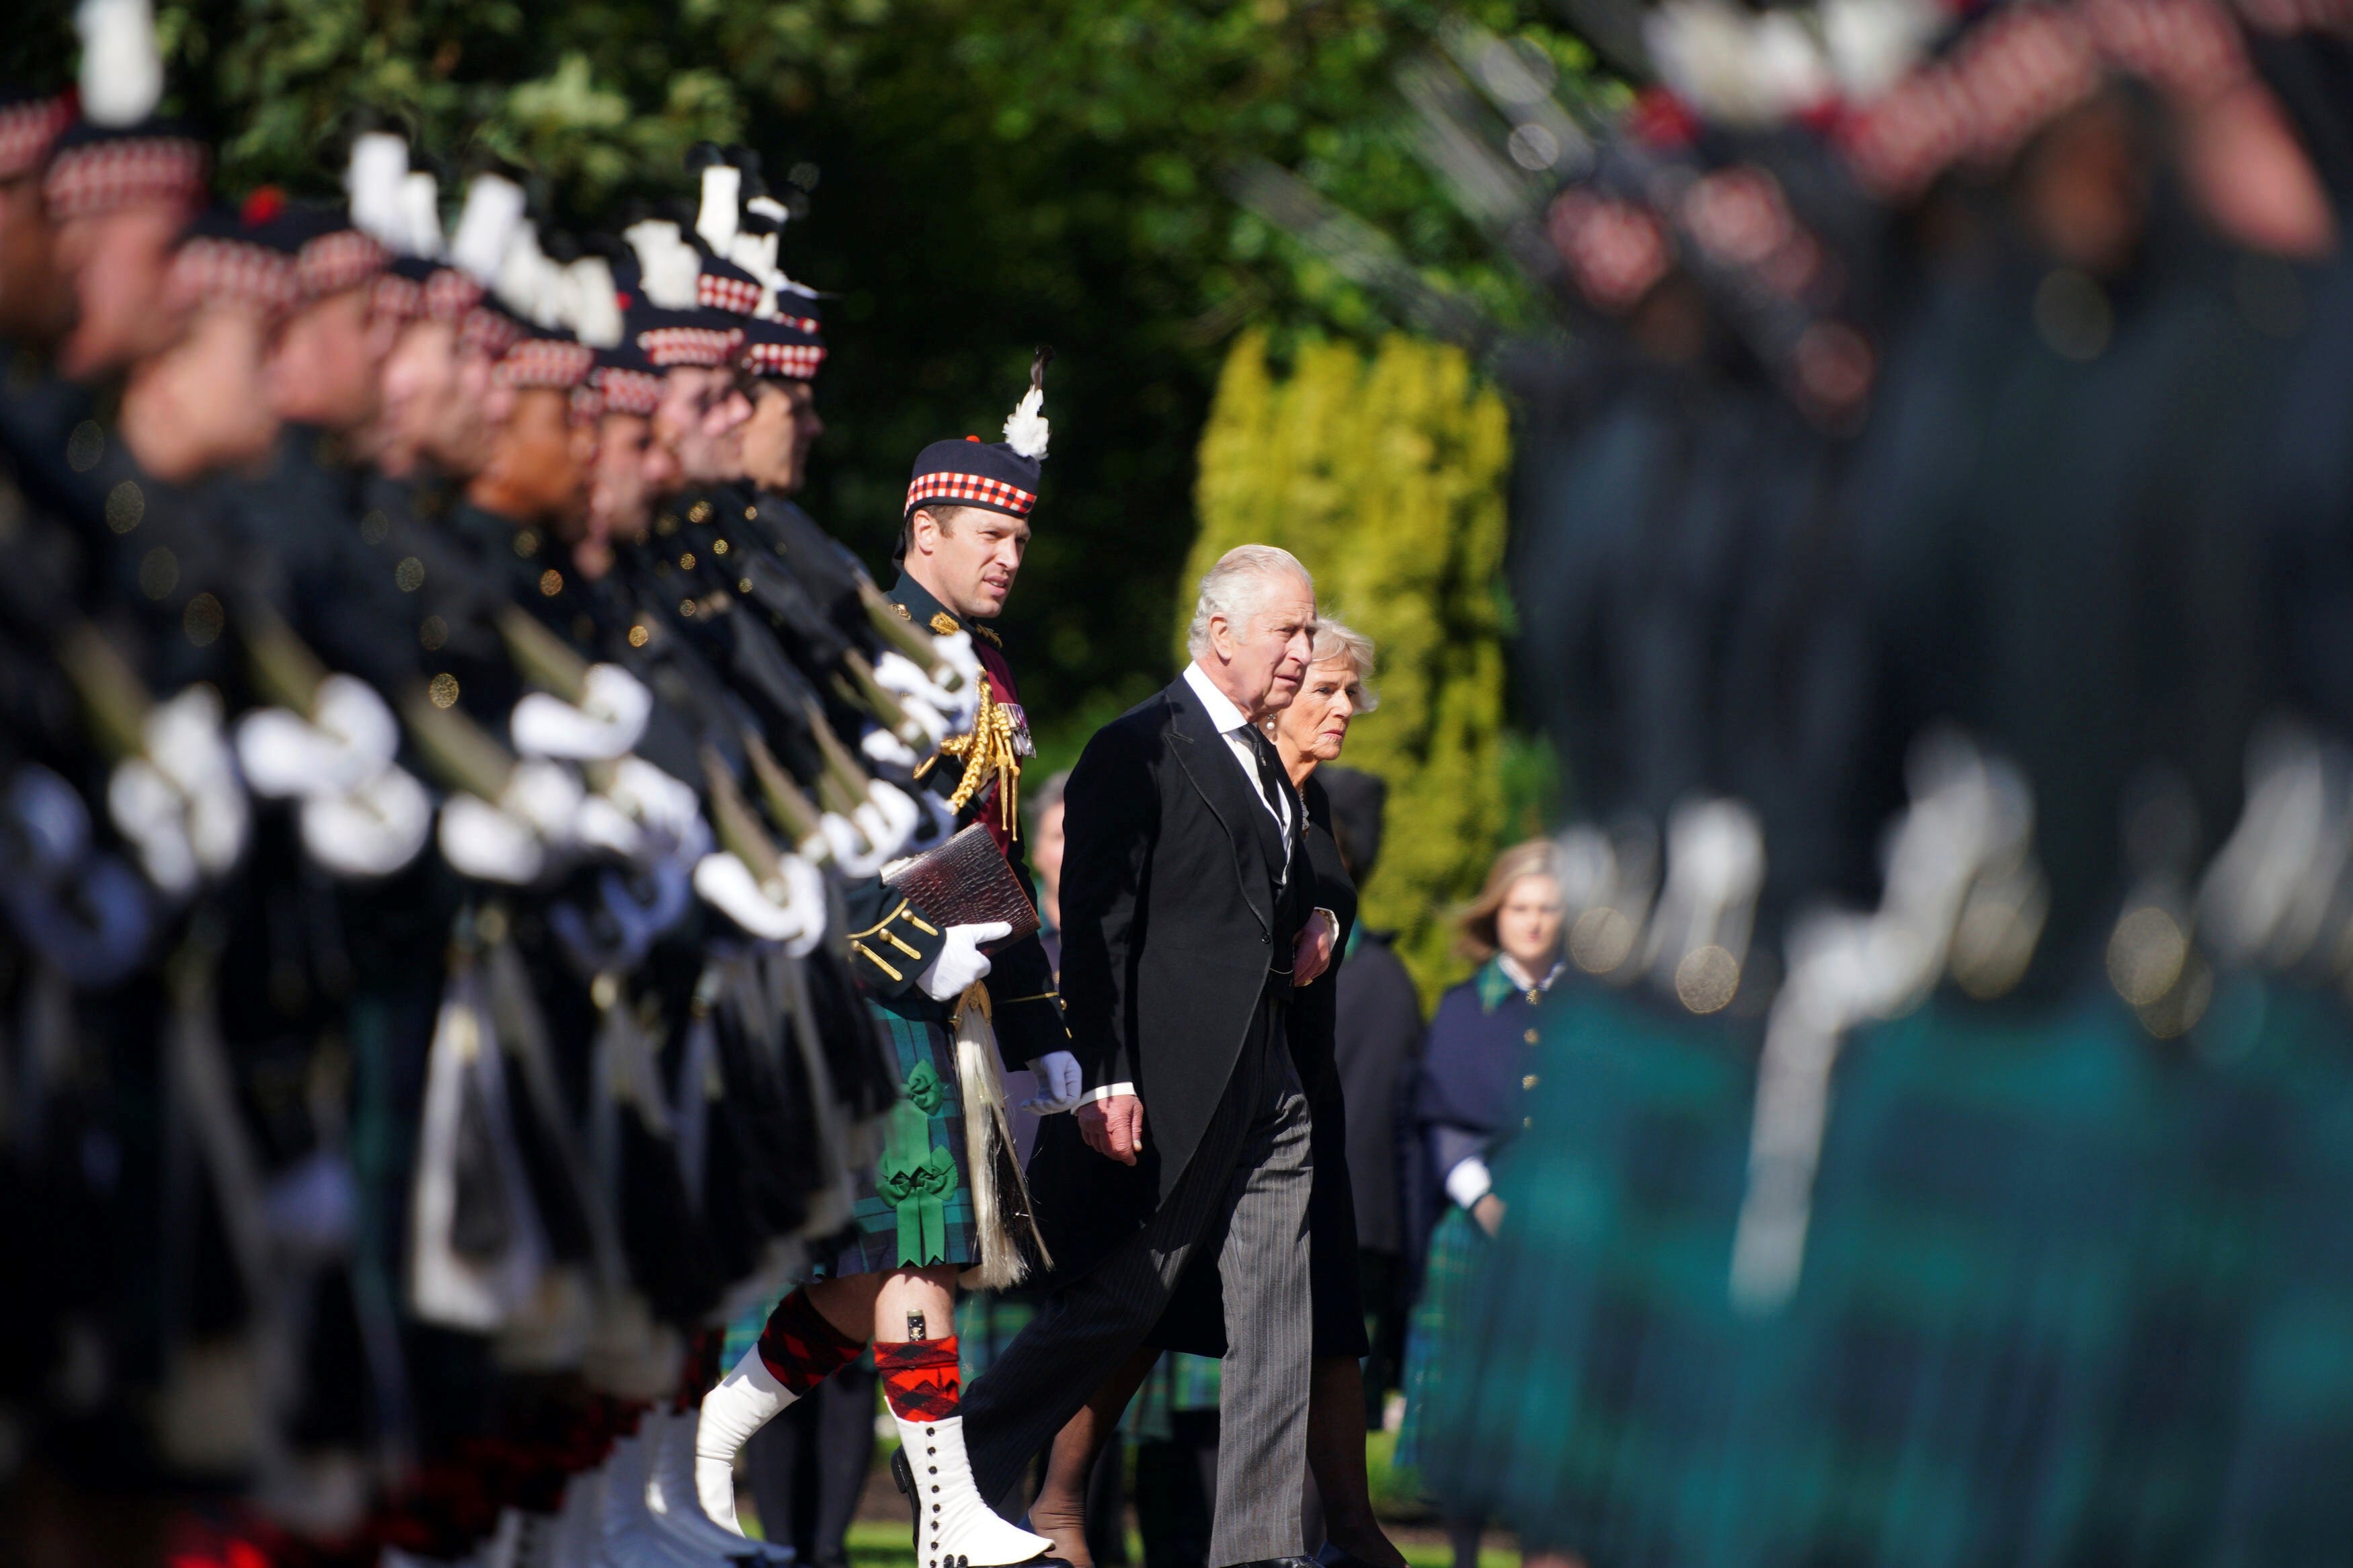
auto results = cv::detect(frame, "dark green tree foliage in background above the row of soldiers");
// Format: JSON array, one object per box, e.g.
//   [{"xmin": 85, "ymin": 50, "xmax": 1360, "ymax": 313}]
[{"xmin": 0, "ymin": 0, "xmax": 1589, "ymax": 733}]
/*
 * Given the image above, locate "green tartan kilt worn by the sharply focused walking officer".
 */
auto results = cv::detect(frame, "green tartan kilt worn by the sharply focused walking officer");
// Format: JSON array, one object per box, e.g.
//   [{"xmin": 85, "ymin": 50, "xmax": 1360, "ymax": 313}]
[{"xmin": 812, "ymin": 997, "xmax": 982, "ymax": 1279}]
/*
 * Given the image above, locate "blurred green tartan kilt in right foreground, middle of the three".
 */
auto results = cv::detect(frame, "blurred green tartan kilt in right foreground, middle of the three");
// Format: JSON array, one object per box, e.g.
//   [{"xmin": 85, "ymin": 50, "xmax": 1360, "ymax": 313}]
[{"xmin": 1720, "ymin": 985, "xmax": 2167, "ymax": 1568}]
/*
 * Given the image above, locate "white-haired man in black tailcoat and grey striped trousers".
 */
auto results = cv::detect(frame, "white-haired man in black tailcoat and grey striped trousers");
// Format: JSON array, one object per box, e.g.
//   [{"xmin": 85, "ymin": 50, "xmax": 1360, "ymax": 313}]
[{"xmin": 965, "ymin": 545, "xmax": 1337, "ymax": 1568}]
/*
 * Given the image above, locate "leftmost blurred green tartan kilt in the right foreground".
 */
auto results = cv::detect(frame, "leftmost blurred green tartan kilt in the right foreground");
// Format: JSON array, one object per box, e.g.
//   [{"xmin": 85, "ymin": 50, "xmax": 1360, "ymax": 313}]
[{"xmin": 1400, "ymin": 987, "xmax": 1755, "ymax": 1566}]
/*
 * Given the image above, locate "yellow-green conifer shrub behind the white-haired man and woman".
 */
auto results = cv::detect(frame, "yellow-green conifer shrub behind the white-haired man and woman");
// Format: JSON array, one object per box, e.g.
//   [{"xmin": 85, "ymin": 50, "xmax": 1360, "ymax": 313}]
[{"xmin": 1195, "ymin": 334, "xmax": 1511, "ymax": 1004}]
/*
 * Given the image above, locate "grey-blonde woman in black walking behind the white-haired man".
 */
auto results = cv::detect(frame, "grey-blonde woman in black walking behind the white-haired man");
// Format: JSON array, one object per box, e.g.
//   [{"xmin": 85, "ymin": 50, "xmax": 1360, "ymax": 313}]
[{"xmin": 1031, "ymin": 620, "xmax": 1405, "ymax": 1568}]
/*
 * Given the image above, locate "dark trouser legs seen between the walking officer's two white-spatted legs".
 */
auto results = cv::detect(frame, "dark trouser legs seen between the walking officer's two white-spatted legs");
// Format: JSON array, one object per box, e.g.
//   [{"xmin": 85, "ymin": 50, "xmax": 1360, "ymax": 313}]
[{"xmin": 744, "ymin": 1364, "xmax": 875, "ymax": 1568}]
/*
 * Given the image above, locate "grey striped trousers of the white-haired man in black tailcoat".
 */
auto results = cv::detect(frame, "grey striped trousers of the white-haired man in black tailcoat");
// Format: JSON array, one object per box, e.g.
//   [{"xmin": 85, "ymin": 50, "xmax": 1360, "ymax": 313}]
[{"xmin": 965, "ymin": 1004, "xmax": 1313, "ymax": 1568}]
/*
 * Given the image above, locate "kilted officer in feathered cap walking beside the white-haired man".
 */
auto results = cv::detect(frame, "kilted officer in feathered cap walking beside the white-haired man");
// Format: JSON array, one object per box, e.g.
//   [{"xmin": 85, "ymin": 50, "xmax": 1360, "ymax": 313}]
[{"xmin": 696, "ymin": 355, "xmax": 1080, "ymax": 1568}]
